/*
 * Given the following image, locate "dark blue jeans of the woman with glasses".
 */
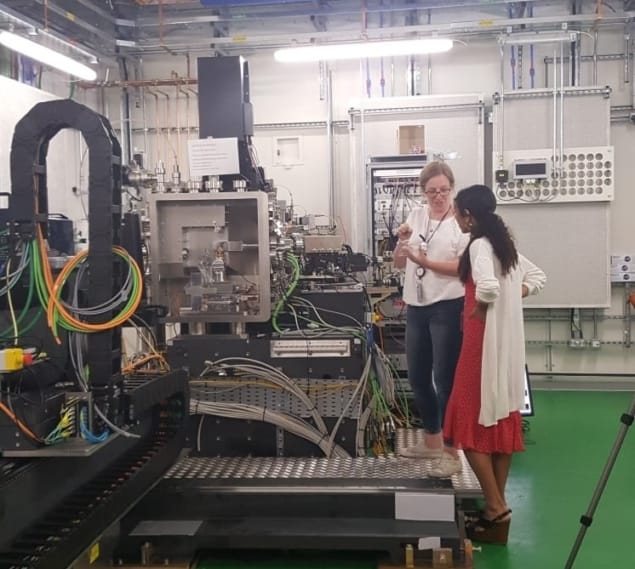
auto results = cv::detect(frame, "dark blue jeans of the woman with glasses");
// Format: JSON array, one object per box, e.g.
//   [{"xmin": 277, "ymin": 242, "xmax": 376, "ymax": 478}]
[{"xmin": 406, "ymin": 297, "xmax": 463, "ymax": 434}]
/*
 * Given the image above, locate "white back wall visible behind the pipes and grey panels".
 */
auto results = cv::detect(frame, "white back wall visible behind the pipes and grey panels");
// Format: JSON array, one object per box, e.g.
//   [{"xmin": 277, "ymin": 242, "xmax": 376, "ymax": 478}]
[{"xmin": 94, "ymin": 29, "xmax": 635, "ymax": 380}]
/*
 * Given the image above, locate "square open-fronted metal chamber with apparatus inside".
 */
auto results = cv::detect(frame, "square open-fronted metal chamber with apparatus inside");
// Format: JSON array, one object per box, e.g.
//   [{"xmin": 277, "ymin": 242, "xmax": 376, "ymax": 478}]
[{"xmin": 149, "ymin": 192, "xmax": 271, "ymax": 323}]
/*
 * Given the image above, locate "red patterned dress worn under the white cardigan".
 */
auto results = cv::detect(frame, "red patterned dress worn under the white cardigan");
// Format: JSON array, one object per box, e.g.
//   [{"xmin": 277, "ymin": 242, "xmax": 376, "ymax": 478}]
[{"xmin": 443, "ymin": 277, "xmax": 524, "ymax": 454}]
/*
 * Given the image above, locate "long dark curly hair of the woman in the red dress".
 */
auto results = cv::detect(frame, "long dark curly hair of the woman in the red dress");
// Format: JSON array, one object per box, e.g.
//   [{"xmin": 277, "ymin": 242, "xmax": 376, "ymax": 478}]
[{"xmin": 454, "ymin": 184, "xmax": 518, "ymax": 283}]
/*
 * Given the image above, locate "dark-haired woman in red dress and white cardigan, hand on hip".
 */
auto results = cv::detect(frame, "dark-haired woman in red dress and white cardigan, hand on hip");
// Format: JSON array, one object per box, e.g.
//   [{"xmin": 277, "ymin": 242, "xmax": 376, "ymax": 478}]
[{"xmin": 433, "ymin": 185, "xmax": 546, "ymax": 543}]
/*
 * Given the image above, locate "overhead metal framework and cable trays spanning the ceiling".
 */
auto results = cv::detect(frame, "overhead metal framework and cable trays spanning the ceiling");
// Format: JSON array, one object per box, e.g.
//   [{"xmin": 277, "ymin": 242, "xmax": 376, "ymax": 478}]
[{"xmin": 0, "ymin": 0, "xmax": 634, "ymax": 57}]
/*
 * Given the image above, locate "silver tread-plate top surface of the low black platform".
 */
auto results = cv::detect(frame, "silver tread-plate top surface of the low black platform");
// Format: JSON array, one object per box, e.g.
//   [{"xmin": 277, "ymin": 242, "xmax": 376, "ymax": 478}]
[{"xmin": 164, "ymin": 429, "xmax": 481, "ymax": 498}]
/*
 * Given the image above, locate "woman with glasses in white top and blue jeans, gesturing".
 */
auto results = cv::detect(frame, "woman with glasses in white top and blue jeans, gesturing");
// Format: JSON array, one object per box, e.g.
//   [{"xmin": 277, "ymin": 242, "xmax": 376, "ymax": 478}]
[{"xmin": 394, "ymin": 162, "xmax": 468, "ymax": 458}]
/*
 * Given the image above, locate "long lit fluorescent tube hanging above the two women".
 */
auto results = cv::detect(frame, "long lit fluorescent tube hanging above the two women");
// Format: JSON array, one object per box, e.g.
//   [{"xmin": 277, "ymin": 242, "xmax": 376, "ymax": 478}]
[{"xmin": 273, "ymin": 38, "xmax": 452, "ymax": 63}]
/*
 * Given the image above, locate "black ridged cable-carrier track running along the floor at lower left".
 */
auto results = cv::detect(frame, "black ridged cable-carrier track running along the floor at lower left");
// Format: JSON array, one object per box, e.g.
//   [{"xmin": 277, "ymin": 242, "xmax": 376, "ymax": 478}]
[{"xmin": 0, "ymin": 370, "xmax": 188, "ymax": 569}]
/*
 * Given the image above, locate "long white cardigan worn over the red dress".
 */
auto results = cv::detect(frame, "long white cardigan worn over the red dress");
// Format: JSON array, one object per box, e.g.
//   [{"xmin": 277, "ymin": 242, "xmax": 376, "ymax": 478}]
[{"xmin": 470, "ymin": 237, "xmax": 546, "ymax": 427}]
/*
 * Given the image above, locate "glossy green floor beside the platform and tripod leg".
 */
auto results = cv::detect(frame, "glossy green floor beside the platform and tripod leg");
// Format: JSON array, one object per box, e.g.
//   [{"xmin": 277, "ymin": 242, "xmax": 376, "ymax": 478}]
[{"xmin": 199, "ymin": 392, "xmax": 635, "ymax": 569}]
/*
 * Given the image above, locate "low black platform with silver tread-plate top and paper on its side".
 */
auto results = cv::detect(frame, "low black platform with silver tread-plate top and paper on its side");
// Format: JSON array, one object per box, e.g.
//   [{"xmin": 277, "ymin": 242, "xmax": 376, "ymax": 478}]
[{"xmin": 115, "ymin": 430, "xmax": 481, "ymax": 562}]
